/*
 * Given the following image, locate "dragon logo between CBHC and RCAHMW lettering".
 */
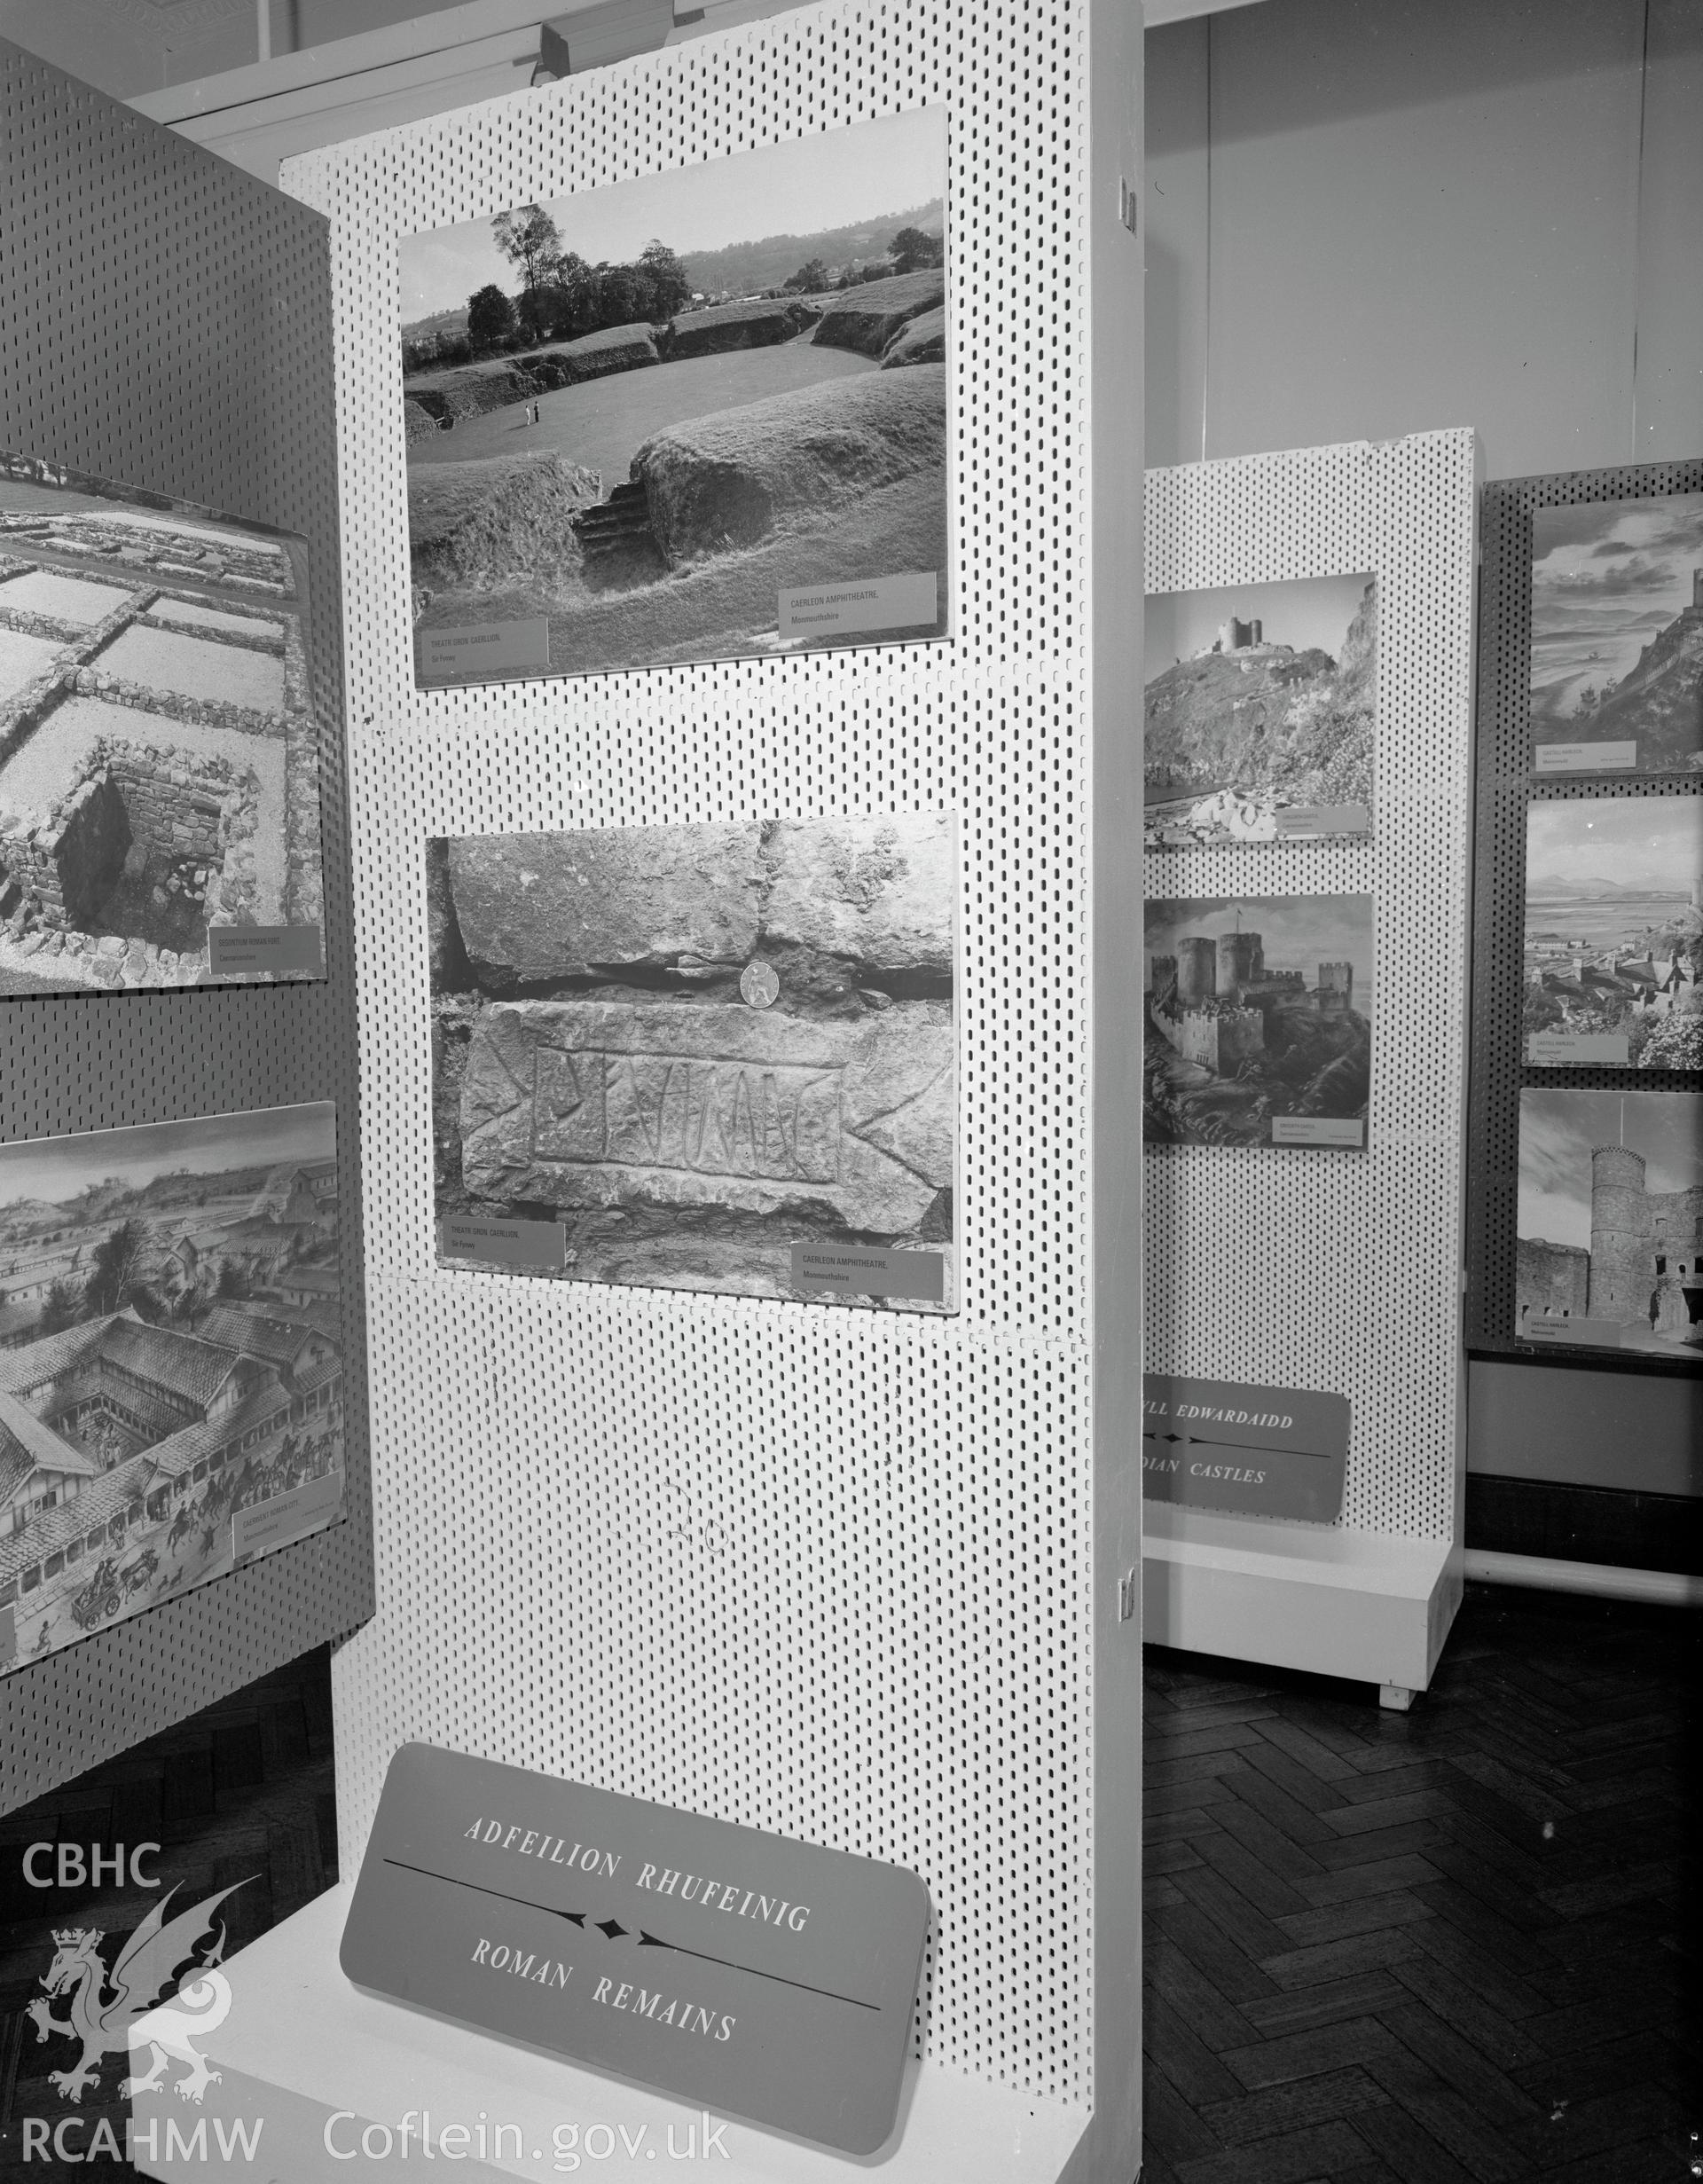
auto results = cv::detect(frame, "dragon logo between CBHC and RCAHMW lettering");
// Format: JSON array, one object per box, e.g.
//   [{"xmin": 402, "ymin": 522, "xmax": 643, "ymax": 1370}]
[{"xmin": 28, "ymin": 1881, "xmax": 247, "ymax": 2103}]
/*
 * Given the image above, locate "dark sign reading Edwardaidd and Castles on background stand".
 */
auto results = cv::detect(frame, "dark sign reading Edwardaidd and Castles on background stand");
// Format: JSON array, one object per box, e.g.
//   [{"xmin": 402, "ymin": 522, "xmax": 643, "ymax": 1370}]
[{"xmin": 1142, "ymin": 1374, "xmax": 1349, "ymax": 1524}]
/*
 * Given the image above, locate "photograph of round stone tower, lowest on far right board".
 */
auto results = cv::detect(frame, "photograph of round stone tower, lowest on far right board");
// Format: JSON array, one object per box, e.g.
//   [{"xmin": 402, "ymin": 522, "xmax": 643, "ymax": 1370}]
[{"xmin": 1513, "ymin": 1086, "xmax": 1703, "ymax": 1363}]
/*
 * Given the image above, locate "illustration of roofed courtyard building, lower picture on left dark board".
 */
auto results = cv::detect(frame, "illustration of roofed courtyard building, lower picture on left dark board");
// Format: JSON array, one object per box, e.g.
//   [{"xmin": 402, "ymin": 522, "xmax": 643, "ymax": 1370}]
[{"xmin": 0, "ymin": 1103, "xmax": 342, "ymax": 1673}]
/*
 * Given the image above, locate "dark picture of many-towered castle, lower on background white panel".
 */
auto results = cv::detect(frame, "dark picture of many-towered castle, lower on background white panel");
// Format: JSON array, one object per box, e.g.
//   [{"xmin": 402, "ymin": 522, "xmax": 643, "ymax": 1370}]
[{"xmin": 1142, "ymin": 895, "xmax": 1373, "ymax": 1151}]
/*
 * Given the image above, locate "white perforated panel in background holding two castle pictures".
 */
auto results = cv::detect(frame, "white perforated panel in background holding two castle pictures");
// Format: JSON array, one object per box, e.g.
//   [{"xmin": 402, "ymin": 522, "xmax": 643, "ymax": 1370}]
[{"xmin": 1146, "ymin": 432, "xmax": 1476, "ymax": 1540}]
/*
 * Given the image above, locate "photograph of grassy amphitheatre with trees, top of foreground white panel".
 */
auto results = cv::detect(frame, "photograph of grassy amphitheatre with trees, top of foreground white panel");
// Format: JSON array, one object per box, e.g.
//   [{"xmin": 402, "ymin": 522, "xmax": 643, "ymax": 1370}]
[{"xmin": 399, "ymin": 107, "xmax": 950, "ymax": 686}]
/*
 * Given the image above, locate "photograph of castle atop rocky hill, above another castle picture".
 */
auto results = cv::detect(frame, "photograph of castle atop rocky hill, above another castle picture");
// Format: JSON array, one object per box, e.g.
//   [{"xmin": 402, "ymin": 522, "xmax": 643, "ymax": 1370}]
[{"xmin": 1144, "ymin": 575, "xmax": 1377, "ymax": 850}]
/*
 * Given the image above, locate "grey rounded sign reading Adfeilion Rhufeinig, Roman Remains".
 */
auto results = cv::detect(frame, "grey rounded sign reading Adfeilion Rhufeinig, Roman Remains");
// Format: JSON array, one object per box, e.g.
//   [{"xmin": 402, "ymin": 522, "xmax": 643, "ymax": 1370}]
[{"xmin": 342, "ymin": 1745, "xmax": 928, "ymax": 2154}]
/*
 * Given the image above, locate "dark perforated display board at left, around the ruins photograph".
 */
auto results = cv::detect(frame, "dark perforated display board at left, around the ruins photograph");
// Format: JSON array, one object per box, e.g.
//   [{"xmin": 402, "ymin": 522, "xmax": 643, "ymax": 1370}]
[{"xmin": 0, "ymin": 43, "xmax": 371, "ymax": 1806}]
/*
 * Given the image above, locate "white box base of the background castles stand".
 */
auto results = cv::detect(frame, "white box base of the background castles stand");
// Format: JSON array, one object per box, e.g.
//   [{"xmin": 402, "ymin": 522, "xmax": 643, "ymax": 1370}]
[{"xmin": 1142, "ymin": 1503, "xmax": 1463, "ymax": 1691}]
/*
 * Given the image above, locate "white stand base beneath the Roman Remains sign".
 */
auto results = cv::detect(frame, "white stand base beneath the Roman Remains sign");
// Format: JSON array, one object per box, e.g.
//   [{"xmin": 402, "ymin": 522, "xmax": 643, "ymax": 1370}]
[{"xmin": 131, "ymin": 1882, "xmax": 1087, "ymax": 2184}]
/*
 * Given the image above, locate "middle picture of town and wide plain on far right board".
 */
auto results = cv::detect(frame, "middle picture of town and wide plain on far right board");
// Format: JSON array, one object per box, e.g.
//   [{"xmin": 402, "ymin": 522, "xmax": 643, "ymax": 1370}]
[{"xmin": 1519, "ymin": 795, "xmax": 1703, "ymax": 1070}]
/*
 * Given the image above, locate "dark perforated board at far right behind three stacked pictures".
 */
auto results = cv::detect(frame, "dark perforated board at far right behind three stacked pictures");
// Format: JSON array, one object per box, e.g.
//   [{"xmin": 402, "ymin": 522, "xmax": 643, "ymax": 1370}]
[{"xmin": 1467, "ymin": 460, "xmax": 1703, "ymax": 1376}]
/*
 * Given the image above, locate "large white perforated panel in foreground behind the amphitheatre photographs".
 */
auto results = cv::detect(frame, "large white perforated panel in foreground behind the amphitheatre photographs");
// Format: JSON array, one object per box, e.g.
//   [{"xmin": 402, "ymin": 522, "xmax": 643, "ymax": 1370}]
[{"xmin": 286, "ymin": 0, "xmax": 1094, "ymax": 2101}]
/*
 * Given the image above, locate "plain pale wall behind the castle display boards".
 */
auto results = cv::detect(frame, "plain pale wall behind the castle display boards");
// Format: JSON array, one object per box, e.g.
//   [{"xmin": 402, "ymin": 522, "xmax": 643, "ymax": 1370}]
[{"xmin": 1146, "ymin": 0, "xmax": 1703, "ymax": 1496}]
